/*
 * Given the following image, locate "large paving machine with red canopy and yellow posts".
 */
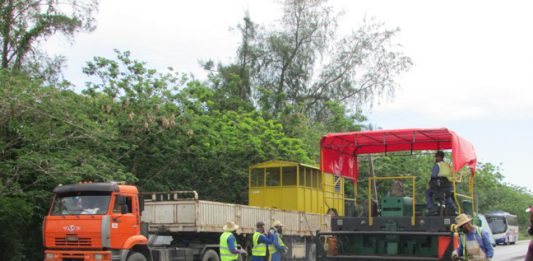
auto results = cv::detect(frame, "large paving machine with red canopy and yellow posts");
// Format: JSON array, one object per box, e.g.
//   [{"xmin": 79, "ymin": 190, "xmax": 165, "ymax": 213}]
[{"xmin": 316, "ymin": 129, "xmax": 476, "ymax": 261}]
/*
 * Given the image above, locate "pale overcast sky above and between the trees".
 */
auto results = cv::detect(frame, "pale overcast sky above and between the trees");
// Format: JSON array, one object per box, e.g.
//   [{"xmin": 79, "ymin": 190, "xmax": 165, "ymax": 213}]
[{"xmin": 46, "ymin": 0, "xmax": 533, "ymax": 190}]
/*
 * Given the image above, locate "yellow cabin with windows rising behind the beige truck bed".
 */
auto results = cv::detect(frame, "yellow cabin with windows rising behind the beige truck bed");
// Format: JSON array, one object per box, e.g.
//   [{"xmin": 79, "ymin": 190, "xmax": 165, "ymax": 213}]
[{"xmin": 248, "ymin": 161, "xmax": 344, "ymax": 216}]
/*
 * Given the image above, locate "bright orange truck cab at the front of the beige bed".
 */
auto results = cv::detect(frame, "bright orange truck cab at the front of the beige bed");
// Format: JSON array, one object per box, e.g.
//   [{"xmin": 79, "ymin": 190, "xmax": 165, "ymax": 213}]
[{"xmin": 43, "ymin": 183, "xmax": 149, "ymax": 261}]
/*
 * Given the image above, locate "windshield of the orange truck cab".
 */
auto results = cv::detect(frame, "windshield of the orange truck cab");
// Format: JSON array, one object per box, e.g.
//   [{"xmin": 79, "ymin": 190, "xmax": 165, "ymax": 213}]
[{"xmin": 51, "ymin": 192, "xmax": 111, "ymax": 216}]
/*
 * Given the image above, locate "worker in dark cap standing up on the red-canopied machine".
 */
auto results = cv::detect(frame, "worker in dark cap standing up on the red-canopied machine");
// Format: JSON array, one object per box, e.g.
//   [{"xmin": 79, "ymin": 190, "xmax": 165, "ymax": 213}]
[{"xmin": 426, "ymin": 150, "xmax": 457, "ymax": 213}]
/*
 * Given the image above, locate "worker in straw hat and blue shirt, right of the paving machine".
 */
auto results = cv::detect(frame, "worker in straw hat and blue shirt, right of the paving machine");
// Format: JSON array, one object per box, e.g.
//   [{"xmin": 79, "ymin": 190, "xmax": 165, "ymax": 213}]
[{"xmin": 452, "ymin": 214, "xmax": 494, "ymax": 261}]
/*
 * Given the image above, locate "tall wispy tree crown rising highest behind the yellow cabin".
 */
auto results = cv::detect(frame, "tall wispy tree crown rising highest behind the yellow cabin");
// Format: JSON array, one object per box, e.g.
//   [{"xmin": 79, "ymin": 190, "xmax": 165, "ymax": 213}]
[{"xmin": 233, "ymin": 0, "xmax": 412, "ymax": 121}]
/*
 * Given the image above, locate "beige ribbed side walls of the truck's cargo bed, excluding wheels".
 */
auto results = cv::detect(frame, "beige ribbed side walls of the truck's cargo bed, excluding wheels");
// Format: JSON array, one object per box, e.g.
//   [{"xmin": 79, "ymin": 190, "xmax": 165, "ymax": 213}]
[{"xmin": 142, "ymin": 196, "xmax": 331, "ymax": 236}]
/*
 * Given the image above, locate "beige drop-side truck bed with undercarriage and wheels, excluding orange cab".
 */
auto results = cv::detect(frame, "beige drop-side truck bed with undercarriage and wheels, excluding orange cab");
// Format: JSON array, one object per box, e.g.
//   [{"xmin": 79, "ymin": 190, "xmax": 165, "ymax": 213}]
[{"xmin": 142, "ymin": 192, "xmax": 331, "ymax": 260}]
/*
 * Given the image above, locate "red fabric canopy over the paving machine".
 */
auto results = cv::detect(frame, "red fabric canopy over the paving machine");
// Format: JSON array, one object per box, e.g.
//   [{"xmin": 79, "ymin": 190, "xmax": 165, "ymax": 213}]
[{"xmin": 320, "ymin": 128, "xmax": 477, "ymax": 180}]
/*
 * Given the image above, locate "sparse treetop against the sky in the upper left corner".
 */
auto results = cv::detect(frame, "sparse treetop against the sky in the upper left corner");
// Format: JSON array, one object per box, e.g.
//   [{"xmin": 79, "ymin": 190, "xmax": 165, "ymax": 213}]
[{"xmin": 0, "ymin": 0, "xmax": 97, "ymax": 77}]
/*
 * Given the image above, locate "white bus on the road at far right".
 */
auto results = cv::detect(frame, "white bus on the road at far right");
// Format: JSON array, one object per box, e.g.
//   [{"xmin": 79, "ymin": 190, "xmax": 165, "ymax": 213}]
[{"xmin": 485, "ymin": 211, "xmax": 518, "ymax": 245}]
